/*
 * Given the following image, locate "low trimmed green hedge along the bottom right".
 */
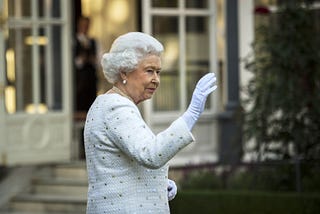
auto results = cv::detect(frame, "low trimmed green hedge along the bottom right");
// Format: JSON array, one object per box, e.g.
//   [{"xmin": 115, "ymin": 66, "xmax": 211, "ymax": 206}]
[{"xmin": 170, "ymin": 191, "xmax": 320, "ymax": 214}]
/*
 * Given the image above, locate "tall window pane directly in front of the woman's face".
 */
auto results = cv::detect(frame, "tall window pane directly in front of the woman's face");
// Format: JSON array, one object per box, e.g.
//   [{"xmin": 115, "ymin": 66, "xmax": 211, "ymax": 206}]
[{"xmin": 152, "ymin": 16, "xmax": 180, "ymax": 111}]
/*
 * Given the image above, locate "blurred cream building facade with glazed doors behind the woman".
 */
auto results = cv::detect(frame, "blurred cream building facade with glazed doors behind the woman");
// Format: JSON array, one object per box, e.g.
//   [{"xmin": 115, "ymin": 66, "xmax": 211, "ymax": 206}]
[{"xmin": 0, "ymin": 0, "xmax": 308, "ymax": 166}]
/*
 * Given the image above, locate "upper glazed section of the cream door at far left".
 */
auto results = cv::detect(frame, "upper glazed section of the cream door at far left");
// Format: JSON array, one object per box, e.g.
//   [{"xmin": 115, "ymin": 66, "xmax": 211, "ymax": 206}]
[{"xmin": 4, "ymin": 0, "xmax": 65, "ymax": 113}]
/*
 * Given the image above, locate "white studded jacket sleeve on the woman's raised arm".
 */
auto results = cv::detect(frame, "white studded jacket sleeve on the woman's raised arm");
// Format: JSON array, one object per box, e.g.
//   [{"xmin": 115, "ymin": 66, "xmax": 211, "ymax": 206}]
[{"xmin": 105, "ymin": 99, "xmax": 194, "ymax": 169}]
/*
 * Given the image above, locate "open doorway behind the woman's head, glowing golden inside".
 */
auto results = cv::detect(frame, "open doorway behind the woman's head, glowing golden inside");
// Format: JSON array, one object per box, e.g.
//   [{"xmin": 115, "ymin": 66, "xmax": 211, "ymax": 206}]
[{"xmin": 73, "ymin": 0, "xmax": 142, "ymax": 160}]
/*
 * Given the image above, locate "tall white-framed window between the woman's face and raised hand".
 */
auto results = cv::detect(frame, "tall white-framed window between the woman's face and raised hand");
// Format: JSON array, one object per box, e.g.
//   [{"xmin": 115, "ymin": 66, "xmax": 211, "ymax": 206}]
[{"xmin": 143, "ymin": 0, "xmax": 217, "ymax": 118}]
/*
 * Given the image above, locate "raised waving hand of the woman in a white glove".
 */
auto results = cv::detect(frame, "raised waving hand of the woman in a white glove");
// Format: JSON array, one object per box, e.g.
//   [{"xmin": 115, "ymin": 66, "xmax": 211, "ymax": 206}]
[{"xmin": 182, "ymin": 73, "xmax": 217, "ymax": 131}]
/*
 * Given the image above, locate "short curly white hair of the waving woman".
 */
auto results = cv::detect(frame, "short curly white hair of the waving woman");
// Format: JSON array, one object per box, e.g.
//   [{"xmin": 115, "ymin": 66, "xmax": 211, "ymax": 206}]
[{"xmin": 101, "ymin": 32, "xmax": 163, "ymax": 84}]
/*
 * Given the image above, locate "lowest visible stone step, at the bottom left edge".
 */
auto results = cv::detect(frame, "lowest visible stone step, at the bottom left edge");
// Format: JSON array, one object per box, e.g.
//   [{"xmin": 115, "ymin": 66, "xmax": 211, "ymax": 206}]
[{"xmin": 10, "ymin": 194, "xmax": 87, "ymax": 214}]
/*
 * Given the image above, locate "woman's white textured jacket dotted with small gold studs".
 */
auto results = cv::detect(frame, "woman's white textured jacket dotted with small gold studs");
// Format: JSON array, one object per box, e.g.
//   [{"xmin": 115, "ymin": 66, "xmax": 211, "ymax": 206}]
[{"xmin": 84, "ymin": 94, "xmax": 194, "ymax": 214}]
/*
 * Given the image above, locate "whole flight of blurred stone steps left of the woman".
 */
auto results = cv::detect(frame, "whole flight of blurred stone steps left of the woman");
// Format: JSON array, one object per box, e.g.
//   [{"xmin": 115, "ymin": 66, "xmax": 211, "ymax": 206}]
[{"xmin": 0, "ymin": 161, "xmax": 88, "ymax": 214}]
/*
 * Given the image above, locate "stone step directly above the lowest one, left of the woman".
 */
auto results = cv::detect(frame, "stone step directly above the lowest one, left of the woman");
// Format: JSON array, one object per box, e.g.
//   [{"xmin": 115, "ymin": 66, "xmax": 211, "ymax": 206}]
[{"xmin": 30, "ymin": 178, "xmax": 88, "ymax": 197}]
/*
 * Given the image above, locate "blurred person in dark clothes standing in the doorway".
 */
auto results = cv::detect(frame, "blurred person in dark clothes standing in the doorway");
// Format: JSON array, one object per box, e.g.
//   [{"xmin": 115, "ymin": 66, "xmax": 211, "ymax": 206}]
[{"xmin": 75, "ymin": 17, "xmax": 97, "ymax": 112}]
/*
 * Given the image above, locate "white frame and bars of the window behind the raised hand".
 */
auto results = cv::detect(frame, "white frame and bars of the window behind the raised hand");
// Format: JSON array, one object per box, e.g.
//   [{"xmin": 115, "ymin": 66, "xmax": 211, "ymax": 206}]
[{"xmin": 142, "ymin": 0, "xmax": 219, "ymax": 124}]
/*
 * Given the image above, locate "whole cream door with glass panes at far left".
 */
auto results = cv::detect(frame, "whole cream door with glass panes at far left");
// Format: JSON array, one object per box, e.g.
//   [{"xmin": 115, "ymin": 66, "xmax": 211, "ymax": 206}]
[{"xmin": 0, "ymin": 0, "xmax": 72, "ymax": 165}]
